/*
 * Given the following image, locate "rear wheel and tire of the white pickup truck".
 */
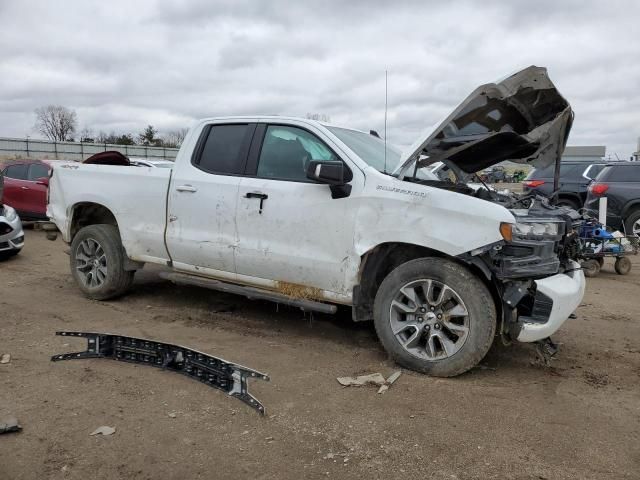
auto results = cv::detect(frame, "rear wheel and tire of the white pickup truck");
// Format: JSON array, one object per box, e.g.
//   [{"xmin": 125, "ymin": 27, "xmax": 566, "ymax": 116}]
[{"xmin": 69, "ymin": 225, "xmax": 135, "ymax": 300}]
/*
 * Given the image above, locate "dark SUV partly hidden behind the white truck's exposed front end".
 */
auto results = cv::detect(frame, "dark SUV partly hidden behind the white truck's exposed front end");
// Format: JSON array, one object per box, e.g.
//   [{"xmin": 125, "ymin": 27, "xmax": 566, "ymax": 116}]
[{"xmin": 522, "ymin": 161, "xmax": 607, "ymax": 210}]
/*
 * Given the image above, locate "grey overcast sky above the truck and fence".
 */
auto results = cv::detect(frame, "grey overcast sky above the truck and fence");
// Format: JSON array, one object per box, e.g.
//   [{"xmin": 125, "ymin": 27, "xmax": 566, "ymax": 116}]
[{"xmin": 0, "ymin": 0, "xmax": 640, "ymax": 158}]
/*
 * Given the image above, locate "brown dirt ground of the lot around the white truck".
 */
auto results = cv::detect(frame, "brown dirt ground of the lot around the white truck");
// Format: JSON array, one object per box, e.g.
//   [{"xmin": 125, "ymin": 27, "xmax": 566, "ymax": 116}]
[{"xmin": 0, "ymin": 230, "xmax": 640, "ymax": 480}]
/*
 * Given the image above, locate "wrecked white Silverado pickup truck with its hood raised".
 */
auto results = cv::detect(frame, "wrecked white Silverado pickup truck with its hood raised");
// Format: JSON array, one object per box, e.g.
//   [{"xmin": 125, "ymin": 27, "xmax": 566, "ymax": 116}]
[{"xmin": 48, "ymin": 67, "xmax": 585, "ymax": 376}]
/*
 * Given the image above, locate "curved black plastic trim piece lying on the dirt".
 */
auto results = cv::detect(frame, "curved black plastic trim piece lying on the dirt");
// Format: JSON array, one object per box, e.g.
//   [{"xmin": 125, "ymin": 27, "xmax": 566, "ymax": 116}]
[{"xmin": 51, "ymin": 332, "xmax": 269, "ymax": 415}]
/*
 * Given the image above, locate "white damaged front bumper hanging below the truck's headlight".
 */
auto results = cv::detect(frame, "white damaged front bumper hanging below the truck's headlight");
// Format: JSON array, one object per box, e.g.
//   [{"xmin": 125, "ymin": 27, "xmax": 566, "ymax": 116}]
[{"xmin": 513, "ymin": 261, "xmax": 586, "ymax": 342}]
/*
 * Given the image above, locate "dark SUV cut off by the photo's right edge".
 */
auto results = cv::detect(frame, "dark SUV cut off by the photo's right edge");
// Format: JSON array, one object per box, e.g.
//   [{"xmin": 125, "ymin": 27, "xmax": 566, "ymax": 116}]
[{"xmin": 584, "ymin": 162, "xmax": 640, "ymax": 236}]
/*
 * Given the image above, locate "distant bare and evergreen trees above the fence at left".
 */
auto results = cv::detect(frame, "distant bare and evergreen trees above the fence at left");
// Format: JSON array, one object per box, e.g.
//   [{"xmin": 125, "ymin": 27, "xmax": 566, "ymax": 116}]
[{"xmin": 34, "ymin": 105, "xmax": 187, "ymax": 148}]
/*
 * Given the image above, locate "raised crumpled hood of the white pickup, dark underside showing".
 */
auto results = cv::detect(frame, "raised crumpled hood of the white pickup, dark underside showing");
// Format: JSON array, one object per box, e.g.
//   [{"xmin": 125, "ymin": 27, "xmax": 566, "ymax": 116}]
[{"xmin": 394, "ymin": 66, "xmax": 573, "ymax": 178}]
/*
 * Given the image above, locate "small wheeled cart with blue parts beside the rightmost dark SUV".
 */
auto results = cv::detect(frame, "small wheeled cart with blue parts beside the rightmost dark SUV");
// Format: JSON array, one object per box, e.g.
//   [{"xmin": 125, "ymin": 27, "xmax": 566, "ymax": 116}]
[{"xmin": 579, "ymin": 220, "xmax": 640, "ymax": 277}]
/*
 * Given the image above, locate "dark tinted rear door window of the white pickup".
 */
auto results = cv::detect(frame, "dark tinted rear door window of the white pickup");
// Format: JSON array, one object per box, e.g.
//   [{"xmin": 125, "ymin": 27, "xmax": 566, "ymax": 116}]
[{"xmin": 196, "ymin": 124, "xmax": 253, "ymax": 175}]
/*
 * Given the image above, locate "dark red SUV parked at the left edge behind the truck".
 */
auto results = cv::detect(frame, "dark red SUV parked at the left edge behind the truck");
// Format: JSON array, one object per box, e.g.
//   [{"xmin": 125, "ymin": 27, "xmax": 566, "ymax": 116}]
[{"xmin": 0, "ymin": 160, "xmax": 52, "ymax": 220}]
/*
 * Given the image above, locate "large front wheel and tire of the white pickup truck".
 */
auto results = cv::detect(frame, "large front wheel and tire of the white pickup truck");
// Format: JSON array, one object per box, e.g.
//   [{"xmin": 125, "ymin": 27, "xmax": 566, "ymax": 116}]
[{"xmin": 374, "ymin": 258, "xmax": 496, "ymax": 377}]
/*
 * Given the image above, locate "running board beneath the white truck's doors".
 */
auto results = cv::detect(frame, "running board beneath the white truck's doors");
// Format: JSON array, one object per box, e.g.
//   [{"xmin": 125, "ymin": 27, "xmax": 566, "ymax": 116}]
[{"xmin": 160, "ymin": 272, "xmax": 338, "ymax": 314}]
